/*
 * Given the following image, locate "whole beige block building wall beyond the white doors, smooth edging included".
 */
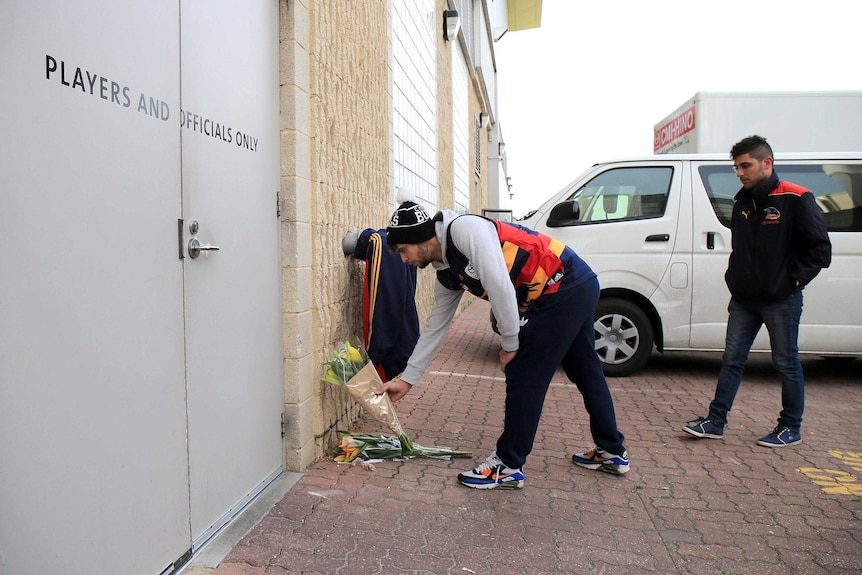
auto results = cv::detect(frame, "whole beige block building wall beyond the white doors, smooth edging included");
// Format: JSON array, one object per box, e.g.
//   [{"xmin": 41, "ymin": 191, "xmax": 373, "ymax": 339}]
[{"xmin": 280, "ymin": 0, "xmax": 487, "ymax": 471}]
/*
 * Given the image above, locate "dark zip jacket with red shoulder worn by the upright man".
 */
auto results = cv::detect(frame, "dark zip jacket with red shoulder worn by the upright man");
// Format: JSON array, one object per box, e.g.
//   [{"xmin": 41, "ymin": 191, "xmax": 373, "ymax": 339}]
[{"xmin": 724, "ymin": 173, "xmax": 832, "ymax": 303}]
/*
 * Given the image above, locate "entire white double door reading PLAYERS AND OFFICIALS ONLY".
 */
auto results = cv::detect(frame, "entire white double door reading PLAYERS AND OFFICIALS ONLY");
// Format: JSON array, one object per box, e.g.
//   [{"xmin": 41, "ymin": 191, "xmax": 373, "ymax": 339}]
[{"xmin": 0, "ymin": 0, "xmax": 283, "ymax": 575}]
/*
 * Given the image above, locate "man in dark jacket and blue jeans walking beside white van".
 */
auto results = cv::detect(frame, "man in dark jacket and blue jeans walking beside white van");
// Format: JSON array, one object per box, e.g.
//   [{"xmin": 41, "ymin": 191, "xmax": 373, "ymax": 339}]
[{"xmin": 683, "ymin": 136, "xmax": 832, "ymax": 447}]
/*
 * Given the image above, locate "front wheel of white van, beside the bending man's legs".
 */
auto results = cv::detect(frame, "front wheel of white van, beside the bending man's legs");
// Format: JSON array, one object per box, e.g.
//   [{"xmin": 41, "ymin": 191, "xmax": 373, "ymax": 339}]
[{"xmin": 593, "ymin": 298, "xmax": 654, "ymax": 377}]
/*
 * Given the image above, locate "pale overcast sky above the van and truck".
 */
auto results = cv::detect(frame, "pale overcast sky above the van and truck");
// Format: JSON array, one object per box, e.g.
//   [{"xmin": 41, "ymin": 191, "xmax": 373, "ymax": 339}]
[{"xmin": 495, "ymin": 0, "xmax": 862, "ymax": 217}]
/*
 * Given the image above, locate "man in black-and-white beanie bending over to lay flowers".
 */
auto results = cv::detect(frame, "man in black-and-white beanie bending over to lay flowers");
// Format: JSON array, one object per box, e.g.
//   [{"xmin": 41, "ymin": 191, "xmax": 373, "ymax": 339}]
[{"xmin": 381, "ymin": 188, "xmax": 629, "ymax": 489}]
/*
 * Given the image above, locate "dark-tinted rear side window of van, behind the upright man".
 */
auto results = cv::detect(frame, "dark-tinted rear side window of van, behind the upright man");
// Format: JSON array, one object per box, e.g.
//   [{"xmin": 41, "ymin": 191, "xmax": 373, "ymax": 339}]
[{"xmin": 698, "ymin": 161, "xmax": 862, "ymax": 232}]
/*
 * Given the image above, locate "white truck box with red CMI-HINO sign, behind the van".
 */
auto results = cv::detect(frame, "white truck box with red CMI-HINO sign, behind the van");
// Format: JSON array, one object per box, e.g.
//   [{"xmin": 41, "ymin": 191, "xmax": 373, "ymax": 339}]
[{"xmin": 653, "ymin": 91, "xmax": 862, "ymax": 154}]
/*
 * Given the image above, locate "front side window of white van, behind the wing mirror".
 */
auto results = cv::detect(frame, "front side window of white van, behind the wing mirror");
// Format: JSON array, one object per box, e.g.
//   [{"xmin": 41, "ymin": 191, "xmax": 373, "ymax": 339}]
[{"xmin": 566, "ymin": 166, "xmax": 673, "ymax": 223}]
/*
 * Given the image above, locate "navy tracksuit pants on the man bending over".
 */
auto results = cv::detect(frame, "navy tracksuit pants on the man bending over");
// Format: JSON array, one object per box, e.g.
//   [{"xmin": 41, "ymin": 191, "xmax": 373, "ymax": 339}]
[{"xmin": 497, "ymin": 277, "xmax": 625, "ymax": 468}]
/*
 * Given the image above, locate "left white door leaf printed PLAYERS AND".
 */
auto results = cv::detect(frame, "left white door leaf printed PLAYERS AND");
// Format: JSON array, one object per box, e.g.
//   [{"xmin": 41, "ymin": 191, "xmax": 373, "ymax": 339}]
[{"xmin": 0, "ymin": 0, "xmax": 190, "ymax": 575}]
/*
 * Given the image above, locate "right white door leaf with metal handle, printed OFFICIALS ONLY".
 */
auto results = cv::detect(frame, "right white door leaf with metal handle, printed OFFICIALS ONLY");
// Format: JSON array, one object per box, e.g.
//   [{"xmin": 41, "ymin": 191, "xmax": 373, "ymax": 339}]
[{"xmin": 181, "ymin": 0, "xmax": 284, "ymax": 546}]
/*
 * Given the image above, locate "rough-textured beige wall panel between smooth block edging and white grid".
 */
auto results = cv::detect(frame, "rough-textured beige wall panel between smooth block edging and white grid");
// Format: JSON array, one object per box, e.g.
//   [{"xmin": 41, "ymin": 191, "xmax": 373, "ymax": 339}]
[{"xmin": 310, "ymin": 0, "xmax": 392, "ymax": 464}]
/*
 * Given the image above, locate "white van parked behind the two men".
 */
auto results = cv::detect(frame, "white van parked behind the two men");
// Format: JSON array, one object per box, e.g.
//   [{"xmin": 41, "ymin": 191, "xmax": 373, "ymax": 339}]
[{"xmin": 518, "ymin": 153, "xmax": 862, "ymax": 376}]
